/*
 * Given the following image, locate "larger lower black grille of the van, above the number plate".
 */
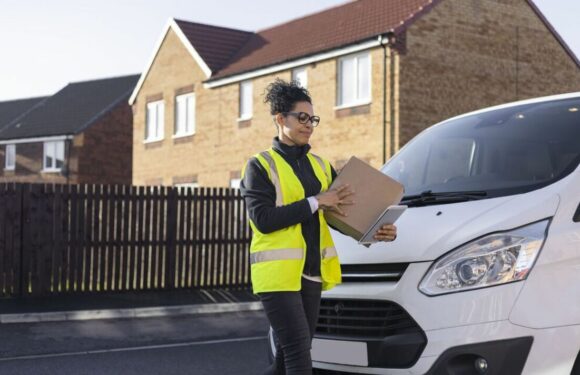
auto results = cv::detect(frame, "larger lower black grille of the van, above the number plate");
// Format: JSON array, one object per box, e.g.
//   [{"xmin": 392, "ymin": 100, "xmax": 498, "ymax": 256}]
[{"xmin": 316, "ymin": 298, "xmax": 422, "ymax": 339}]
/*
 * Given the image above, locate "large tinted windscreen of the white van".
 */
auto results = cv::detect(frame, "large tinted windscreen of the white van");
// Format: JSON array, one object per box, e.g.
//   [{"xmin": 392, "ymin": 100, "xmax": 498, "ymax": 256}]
[{"xmin": 382, "ymin": 98, "xmax": 580, "ymax": 198}]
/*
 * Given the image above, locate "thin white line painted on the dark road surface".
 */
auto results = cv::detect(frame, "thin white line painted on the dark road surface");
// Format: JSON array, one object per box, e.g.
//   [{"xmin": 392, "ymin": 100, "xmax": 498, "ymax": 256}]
[{"xmin": 0, "ymin": 336, "xmax": 266, "ymax": 362}]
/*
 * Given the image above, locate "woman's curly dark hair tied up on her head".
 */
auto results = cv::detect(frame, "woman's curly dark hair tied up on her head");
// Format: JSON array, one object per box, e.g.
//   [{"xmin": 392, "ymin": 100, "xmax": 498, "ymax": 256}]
[{"xmin": 264, "ymin": 78, "xmax": 312, "ymax": 116}]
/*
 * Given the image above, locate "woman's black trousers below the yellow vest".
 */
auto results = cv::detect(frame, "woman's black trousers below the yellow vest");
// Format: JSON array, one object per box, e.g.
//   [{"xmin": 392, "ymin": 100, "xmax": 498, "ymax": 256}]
[{"xmin": 259, "ymin": 278, "xmax": 322, "ymax": 375}]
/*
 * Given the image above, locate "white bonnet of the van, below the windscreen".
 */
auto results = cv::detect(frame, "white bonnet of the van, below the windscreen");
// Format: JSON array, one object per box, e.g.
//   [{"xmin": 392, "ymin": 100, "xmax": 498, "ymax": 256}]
[{"xmin": 332, "ymin": 189, "xmax": 559, "ymax": 264}]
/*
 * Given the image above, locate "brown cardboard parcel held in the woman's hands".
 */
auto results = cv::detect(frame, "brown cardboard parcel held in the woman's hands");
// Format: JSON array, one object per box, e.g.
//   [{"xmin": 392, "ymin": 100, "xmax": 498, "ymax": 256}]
[{"xmin": 324, "ymin": 156, "xmax": 404, "ymax": 241}]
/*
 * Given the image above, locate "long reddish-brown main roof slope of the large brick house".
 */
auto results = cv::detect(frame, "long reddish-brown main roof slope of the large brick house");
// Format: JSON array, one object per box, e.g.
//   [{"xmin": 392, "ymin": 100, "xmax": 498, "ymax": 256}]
[{"xmin": 210, "ymin": 0, "xmax": 440, "ymax": 81}]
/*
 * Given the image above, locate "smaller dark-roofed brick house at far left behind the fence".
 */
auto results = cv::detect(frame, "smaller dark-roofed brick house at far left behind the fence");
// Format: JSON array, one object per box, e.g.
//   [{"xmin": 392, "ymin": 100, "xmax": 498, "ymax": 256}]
[{"xmin": 0, "ymin": 75, "xmax": 139, "ymax": 184}]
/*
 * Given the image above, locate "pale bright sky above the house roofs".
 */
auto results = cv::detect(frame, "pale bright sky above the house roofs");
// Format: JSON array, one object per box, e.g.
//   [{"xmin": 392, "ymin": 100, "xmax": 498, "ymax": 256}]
[{"xmin": 0, "ymin": 0, "xmax": 580, "ymax": 101}]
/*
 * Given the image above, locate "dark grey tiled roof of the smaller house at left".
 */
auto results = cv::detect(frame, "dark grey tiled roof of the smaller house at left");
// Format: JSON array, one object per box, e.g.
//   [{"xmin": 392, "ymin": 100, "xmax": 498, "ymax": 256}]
[{"xmin": 0, "ymin": 75, "xmax": 139, "ymax": 140}]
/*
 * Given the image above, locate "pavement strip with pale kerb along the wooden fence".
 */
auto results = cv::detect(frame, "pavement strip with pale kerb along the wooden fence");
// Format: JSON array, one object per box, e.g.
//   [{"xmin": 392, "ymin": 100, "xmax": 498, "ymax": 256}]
[{"xmin": 0, "ymin": 289, "xmax": 262, "ymax": 324}]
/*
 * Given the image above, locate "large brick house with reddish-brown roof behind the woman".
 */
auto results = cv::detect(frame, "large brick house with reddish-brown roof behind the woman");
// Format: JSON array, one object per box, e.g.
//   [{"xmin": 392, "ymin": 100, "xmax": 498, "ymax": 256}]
[{"xmin": 129, "ymin": 0, "xmax": 580, "ymax": 186}]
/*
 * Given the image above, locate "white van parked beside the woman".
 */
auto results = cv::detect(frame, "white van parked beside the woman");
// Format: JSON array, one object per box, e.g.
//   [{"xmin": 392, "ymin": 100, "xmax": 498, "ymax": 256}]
[{"xmin": 270, "ymin": 93, "xmax": 580, "ymax": 375}]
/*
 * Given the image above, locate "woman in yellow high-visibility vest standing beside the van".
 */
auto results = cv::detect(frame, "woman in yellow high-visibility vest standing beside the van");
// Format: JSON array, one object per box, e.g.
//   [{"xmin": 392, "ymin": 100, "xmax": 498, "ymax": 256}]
[{"xmin": 241, "ymin": 79, "xmax": 396, "ymax": 375}]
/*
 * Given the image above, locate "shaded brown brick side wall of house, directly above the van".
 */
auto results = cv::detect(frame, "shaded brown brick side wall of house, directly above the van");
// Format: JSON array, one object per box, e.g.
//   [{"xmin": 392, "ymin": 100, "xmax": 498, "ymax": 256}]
[{"xmin": 400, "ymin": 0, "xmax": 580, "ymax": 145}]
